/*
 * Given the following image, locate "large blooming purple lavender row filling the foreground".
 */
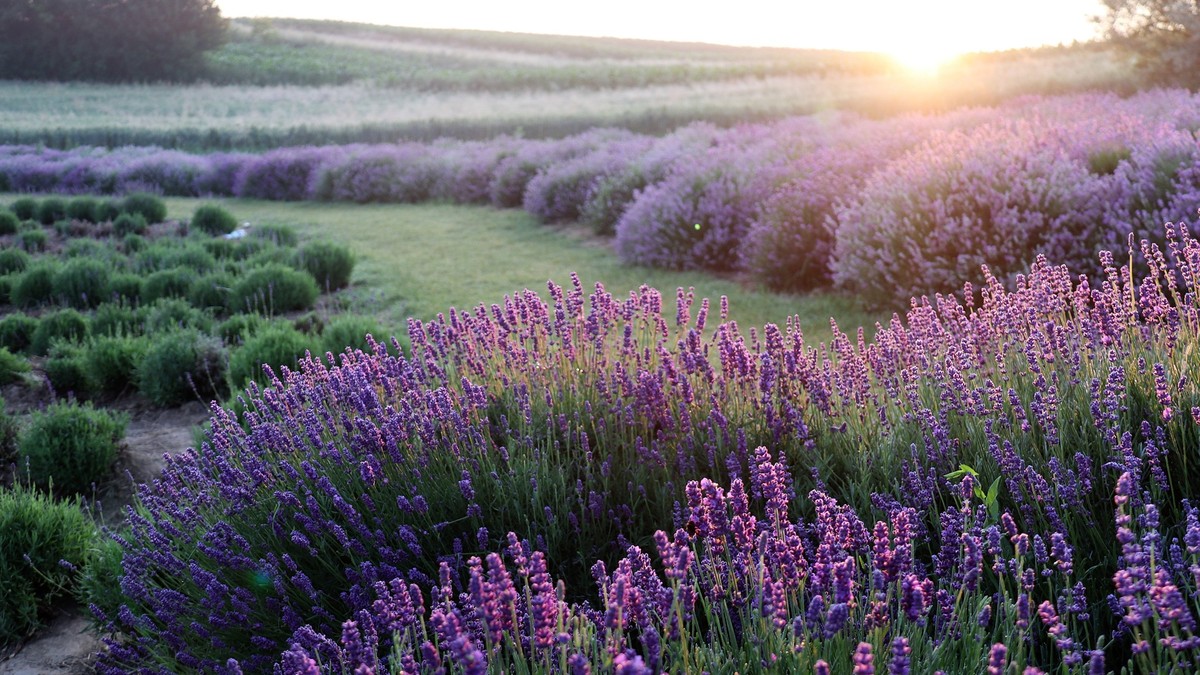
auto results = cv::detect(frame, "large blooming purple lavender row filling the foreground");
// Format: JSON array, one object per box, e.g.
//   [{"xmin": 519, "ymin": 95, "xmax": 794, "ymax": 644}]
[{"xmin": 92, "ymin": 218, "xmax": 1200, "ymax": 674}]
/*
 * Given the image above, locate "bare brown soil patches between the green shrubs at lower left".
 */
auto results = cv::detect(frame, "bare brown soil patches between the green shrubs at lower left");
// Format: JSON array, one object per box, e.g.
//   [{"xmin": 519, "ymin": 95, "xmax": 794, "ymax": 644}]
[{"xmin": 0, "ymin": 374, "xmax": 209, "ymax": 675}]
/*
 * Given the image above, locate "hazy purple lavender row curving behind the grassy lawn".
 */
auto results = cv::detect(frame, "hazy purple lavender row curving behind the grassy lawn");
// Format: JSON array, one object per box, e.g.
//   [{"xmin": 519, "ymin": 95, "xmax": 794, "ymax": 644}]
[{"xmin": 7, "ymin": 91, "xmax": 1200, "ymax": 303}]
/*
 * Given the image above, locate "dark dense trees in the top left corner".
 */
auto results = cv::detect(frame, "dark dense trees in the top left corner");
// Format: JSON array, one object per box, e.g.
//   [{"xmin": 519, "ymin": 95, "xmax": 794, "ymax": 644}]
[{"xmin": 0, "ymin": 0, "xmax": 227, "ymax": 82}]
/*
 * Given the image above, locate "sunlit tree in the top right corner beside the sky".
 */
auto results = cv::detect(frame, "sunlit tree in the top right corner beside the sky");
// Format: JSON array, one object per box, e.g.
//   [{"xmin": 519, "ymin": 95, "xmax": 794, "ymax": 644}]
[{"xmin": 1099, "ymin": 0, "xmax": 1200, "ymax": 88}]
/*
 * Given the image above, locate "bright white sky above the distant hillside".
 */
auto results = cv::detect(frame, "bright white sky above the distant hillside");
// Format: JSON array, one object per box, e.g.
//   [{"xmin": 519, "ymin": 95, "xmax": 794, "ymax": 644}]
[{"xmin": 217, "ymin": 0, "xmax": 1102, "ymax": 62}]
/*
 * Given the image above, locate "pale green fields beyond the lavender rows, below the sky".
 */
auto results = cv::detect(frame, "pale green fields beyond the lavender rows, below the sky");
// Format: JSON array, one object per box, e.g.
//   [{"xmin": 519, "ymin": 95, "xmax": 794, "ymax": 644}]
[{"xmin": 0, "ymin": 20, "xmax": 1134, "ymax": 150}]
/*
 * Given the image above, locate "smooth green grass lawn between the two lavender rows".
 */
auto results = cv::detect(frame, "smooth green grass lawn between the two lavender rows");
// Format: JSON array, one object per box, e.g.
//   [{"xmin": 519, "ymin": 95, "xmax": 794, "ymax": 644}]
[{"xmin": 167, "ymin": 198, "xmax": 890, "ymax": 340}]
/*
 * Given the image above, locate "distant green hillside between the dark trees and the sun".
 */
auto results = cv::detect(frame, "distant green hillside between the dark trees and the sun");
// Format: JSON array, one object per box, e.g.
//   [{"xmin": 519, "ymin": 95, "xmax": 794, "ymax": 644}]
[{"xmin": 209, "ymin": 19, "xmax": 895, "ymax": 91}]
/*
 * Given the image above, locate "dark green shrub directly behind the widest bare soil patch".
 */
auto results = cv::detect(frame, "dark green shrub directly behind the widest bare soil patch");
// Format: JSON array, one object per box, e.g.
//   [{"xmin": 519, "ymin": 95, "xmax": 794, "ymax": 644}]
[{"xmin": 137, "ymin": 329, "xmax": 229, "ymax": 406}]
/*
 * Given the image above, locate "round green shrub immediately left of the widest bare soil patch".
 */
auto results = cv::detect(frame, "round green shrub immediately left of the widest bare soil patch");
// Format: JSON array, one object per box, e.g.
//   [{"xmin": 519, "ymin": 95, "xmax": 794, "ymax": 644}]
[{"xmin": 18, "ymin": 402, "xmax": 128, "ymax": 492}]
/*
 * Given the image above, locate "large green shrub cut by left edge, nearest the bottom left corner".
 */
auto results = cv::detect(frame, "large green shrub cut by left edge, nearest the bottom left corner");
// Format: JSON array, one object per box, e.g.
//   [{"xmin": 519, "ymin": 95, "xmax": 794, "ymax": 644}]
[{"xmin": 0, "ymin": 484, "xmax": 96, "ymax": 646}]
